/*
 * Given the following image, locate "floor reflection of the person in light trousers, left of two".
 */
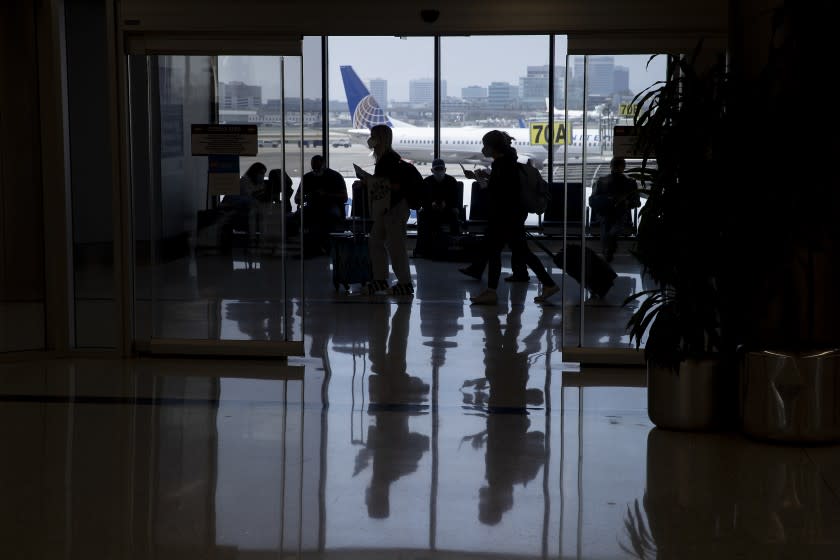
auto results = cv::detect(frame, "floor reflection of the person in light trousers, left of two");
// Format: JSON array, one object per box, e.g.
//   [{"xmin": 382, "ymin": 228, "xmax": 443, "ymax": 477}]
[{"xmin": 353, "ymin": 304, "xmax": 429, "ymax": 518}]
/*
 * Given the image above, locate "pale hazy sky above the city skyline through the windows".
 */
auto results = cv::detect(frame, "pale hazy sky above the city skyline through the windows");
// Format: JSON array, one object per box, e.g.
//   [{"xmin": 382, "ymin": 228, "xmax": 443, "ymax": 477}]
[{"xmin": 219, "ymin": 35, "xmax": 665, "ymax": 101}]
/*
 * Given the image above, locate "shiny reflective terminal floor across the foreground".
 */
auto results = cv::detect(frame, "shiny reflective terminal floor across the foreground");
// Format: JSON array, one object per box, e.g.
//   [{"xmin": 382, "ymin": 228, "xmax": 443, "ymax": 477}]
[{"xmin": 0, "ymin": 258, "xmax": 840, "ymax": 559}]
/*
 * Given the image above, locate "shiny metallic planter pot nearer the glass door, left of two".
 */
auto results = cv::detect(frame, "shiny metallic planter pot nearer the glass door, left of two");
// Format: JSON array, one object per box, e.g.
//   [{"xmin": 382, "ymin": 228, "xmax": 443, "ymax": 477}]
[{"xmin": 648, "ymin": 358, "xmax": 738, "ymax": 430}]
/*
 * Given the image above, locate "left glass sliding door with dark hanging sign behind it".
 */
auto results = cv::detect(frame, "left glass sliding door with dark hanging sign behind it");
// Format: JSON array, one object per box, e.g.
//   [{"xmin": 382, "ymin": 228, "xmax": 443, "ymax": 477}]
[{"xmin": 128, "ymin": 48, "xmax": 304, "ymax": 356}]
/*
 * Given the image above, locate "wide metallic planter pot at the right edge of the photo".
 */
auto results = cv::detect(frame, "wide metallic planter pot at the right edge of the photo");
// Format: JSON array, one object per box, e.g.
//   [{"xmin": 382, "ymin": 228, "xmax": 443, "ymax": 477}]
[{"xmin": 740, "ymin": 349, "xmax": 840, "ymax": 443}]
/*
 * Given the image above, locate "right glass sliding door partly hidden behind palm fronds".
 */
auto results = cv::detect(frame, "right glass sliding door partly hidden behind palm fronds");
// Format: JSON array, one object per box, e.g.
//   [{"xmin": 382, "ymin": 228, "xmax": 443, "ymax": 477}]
[{"xmin": 555, "ymin": 52, "xmax": 665, "ymax": 363}]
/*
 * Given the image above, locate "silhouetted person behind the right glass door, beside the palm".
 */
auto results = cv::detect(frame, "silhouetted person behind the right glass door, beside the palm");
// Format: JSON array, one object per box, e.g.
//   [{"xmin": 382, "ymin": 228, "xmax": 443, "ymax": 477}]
[{"xmin": 589, "ymin": 156, "xmax": 641, "ymax": 262}]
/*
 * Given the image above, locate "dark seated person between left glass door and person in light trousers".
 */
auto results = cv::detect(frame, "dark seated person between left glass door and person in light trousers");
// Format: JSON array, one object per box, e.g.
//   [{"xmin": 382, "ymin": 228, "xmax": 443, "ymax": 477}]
[{"xmin": 295, "ymin": 155, "xmax": 347, "ymax": 252}]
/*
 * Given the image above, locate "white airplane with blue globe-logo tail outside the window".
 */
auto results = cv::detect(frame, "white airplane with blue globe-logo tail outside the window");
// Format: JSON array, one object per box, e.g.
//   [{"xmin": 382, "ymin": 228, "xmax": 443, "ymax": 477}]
[{"xmin": 341, "ymin": 66, "xmax": 600, "ymax": 169}]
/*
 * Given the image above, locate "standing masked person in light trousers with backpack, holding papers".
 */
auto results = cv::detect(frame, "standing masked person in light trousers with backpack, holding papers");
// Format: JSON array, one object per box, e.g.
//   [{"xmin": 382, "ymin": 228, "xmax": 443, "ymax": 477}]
[{"xmin": 359, "ymin": 124, "xmax": 423, "ymax": 296}]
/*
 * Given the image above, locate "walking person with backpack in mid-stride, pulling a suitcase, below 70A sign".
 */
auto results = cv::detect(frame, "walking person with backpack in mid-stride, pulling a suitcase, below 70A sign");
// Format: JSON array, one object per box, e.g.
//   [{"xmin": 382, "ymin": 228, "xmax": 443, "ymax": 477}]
[{"xmin": 470, "ymin": 130, "xmax": 560, "ymax": 305}]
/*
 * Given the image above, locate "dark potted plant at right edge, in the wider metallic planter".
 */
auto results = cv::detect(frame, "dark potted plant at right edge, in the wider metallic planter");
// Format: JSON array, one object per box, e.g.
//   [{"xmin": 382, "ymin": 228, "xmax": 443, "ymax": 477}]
[{"xmin": 724, "ymin": 1, "xmax": 840, "ymax": 442}]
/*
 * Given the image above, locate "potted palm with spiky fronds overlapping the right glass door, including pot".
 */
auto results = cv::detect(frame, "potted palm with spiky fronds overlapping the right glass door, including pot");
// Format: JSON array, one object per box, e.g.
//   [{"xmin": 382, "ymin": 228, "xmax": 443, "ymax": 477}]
[{"xmin": 625, "ymin": 42, "xmax": 737, "ymax": 430}]
